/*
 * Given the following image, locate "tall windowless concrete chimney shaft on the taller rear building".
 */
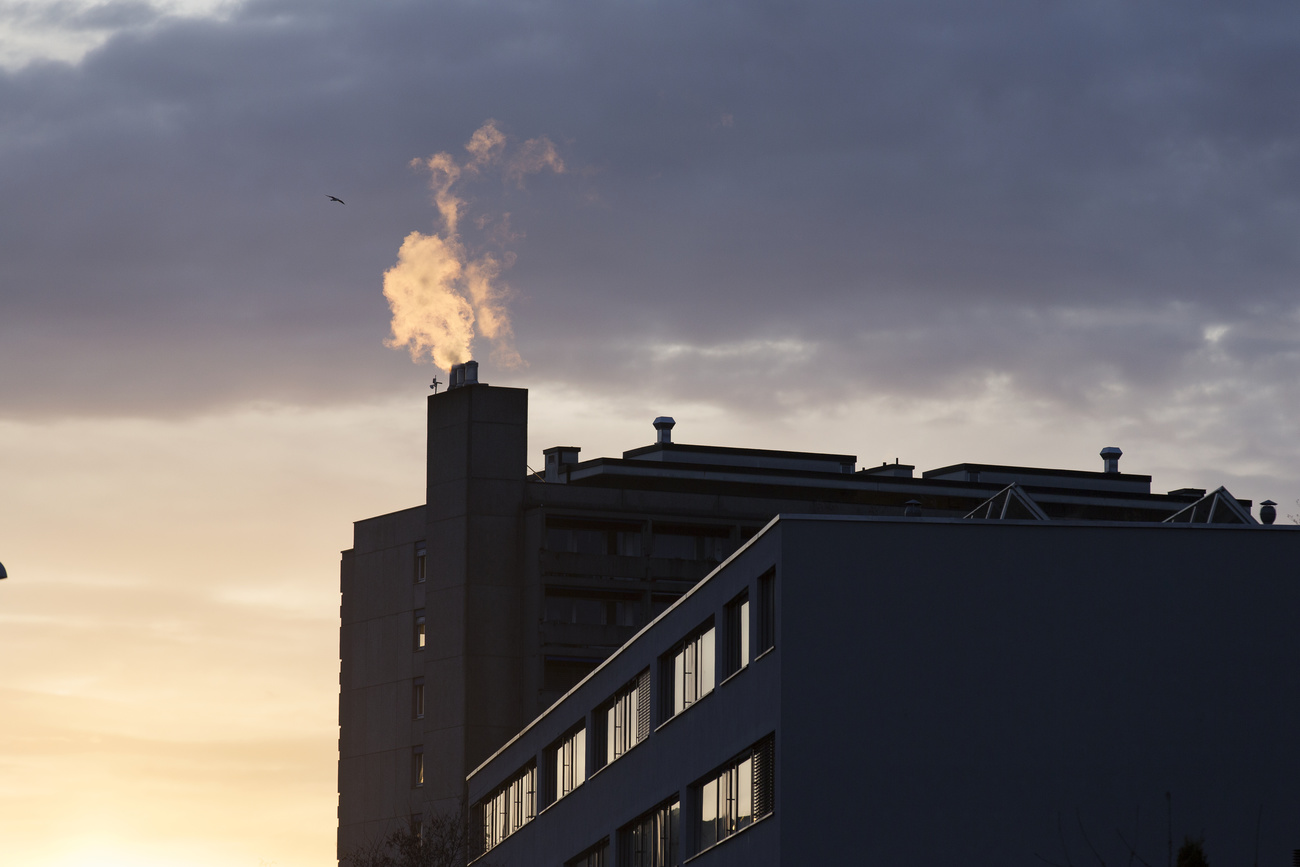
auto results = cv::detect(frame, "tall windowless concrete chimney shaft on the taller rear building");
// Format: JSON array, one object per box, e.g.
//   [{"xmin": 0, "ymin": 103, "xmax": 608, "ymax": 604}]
[{"xmin": 424, "ymin": 385, "xmax": 533, "ymax": 810}]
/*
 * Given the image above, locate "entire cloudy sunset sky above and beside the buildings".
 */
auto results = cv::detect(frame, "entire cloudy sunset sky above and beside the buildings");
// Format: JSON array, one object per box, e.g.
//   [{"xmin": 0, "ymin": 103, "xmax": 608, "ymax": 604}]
[{"xmin": 0, "ymin": 0, "xmax": 1300, "ymax": 867}]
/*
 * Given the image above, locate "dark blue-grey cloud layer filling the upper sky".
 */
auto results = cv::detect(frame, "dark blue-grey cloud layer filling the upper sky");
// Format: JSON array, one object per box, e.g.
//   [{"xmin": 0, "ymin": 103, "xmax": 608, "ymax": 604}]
[{"xmin": 0, "ymin": 0, "xmax": 1300, "ymax": 413}]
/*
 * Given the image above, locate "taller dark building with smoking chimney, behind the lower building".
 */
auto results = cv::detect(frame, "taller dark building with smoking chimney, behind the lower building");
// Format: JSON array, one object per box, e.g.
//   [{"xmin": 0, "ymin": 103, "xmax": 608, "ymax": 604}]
[{"xmin": 338, "ymin": 370, "xmax": 1279, "ymax": 858}]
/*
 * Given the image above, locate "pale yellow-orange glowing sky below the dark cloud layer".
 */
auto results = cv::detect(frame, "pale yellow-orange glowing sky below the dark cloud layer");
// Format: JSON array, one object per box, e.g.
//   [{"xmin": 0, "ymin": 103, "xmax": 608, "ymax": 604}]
[{"xmin": 0, "ymin": 370, "xmax": 1282, "ymax": 867}]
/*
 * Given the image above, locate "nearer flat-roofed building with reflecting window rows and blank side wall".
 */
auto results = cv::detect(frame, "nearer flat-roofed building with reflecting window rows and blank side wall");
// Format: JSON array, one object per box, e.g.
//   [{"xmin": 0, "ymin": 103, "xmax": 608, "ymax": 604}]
[{"xmin": 469, "ymin": 515, "xmax": 1300, "ymax": 867}]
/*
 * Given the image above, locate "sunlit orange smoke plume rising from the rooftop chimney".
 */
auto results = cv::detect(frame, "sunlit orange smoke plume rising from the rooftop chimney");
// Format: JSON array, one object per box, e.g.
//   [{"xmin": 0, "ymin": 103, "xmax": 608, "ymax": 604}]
[{"xmin": 384, "ymin": 121, "xmax": 564, "ymax": 369}]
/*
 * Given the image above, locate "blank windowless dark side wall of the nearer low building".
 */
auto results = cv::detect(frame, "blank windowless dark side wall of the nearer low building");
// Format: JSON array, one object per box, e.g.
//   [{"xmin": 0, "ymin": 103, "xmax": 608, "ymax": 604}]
[{"xmin": 777, "ymin": 519, "xmax": 1300, "ymax": 867}]
